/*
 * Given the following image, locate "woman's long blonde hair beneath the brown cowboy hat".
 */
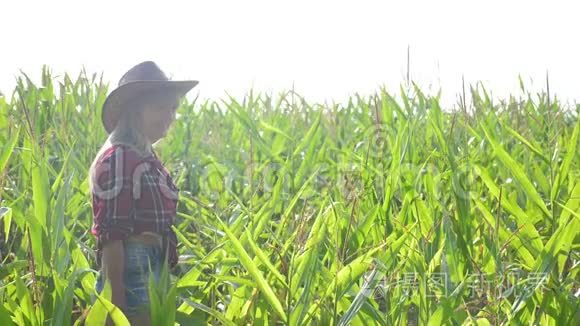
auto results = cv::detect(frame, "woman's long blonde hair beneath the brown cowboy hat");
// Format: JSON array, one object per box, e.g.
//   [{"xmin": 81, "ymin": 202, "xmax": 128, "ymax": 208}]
[{"xmin": 88, "ymin": 91, "xmax": 175, "ymax": 191}]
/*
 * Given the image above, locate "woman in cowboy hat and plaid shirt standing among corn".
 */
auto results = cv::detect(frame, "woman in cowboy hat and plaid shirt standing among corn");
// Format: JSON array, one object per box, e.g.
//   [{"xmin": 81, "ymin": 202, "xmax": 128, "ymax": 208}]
[{"xmin": 89, "ymin": 61, "xmax": 198, "ymax": 325}]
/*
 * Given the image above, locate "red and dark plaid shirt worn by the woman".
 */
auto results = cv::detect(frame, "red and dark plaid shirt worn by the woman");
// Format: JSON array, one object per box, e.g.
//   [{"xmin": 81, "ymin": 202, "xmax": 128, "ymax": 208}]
[{"xmin": 91, "ymin": 145, "xmax": 179, "ymax": 268}]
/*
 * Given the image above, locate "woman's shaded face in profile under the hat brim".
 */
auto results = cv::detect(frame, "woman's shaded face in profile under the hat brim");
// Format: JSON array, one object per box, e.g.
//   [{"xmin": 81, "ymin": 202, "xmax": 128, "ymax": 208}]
[{"xmin": 142, "ymin": 99, "xmax": 179, "ymax": 143}]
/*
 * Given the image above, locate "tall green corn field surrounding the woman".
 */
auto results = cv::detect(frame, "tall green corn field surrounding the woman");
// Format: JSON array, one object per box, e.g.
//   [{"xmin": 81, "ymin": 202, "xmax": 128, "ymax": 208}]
[{"xmin": 0, "ymin": 67, "xmax": 580, "ymax": 325}]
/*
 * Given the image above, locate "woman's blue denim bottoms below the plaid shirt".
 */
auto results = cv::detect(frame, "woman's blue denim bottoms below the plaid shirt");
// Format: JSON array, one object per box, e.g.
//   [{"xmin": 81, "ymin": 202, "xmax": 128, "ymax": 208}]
[{"xmin": 95, "ymin": 241, "xmax": 162, "ymax": 317}]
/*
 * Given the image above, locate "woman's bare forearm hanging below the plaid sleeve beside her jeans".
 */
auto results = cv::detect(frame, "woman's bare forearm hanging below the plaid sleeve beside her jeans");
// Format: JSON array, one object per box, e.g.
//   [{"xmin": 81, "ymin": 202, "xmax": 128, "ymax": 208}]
[{"xmin": 101, "ymin": 240, "xmax": 127, "ymax": 320}]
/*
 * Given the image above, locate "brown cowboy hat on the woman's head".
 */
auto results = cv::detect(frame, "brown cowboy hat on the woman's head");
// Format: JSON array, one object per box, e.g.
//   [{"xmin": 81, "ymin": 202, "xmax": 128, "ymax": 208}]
[{"xmin": 101, "ymin": 61, "xmax": 199, "ymax": 134}]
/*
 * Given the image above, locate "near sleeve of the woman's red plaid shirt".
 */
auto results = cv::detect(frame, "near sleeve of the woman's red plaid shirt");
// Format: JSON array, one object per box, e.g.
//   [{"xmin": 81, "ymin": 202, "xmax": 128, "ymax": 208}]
[{"xmin": 93, "ymin": 147, "xmax": 144, "ymax": 243}]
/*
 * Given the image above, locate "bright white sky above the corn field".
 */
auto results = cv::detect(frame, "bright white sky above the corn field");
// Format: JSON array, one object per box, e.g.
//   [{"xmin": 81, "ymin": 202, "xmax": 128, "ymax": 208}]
[{"xmin": 0, "ymin": 0, "xmax": 580, "ymax": 107}]
